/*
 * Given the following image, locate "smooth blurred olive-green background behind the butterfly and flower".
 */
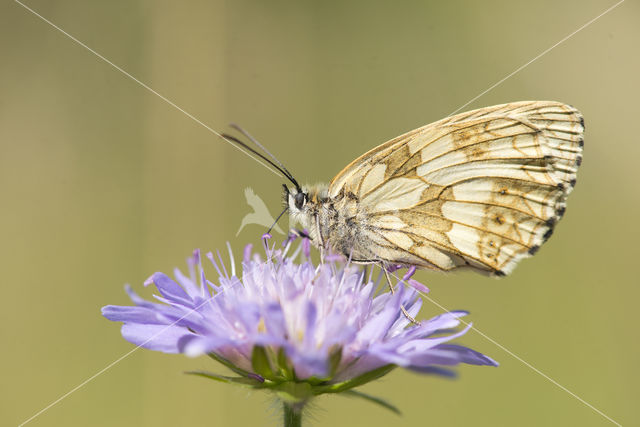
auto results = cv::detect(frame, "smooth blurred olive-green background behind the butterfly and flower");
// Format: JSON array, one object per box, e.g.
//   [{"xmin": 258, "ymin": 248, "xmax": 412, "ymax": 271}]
[{"xmin": 0, "ymin": 0, "xmax": 640, "ymax": 427}]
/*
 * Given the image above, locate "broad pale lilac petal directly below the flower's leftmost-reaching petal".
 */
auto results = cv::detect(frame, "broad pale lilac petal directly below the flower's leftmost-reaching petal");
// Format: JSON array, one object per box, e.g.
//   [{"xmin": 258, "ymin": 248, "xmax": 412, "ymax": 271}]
[{"xmin": 121, "ymin": 323, "xmax": 191, "ymax": 353}]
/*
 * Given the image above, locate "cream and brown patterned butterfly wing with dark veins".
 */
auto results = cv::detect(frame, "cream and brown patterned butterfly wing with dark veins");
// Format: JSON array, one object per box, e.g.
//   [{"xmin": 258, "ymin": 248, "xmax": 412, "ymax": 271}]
[{"xmin": 329, "ymin": 101, "xmax": 584, "ymax": 275}]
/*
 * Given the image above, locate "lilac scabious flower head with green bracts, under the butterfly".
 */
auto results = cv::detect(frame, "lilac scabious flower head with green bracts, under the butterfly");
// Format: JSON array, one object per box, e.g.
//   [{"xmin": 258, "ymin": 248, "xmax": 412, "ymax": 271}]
[{"xmin": 102, "ymin": 241, "xmax": 497, "ymax": 412}]
